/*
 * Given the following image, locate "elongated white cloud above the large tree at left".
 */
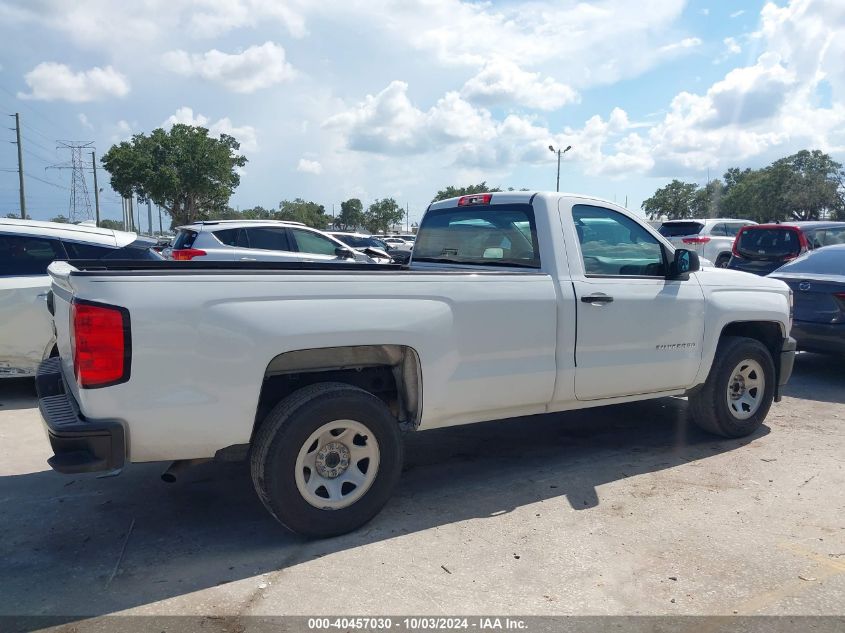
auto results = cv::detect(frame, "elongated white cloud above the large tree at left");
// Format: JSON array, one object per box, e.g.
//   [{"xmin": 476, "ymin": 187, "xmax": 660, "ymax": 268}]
[{"xmin": 162, "ymin": 42, "xmax": 296, "ymax": 94}]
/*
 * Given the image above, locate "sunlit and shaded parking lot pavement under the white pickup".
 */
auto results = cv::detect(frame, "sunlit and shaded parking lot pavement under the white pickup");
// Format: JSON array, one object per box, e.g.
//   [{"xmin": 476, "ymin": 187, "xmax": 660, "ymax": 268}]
[{"xmin": 0, "ymin": 354, "xmax": 845, "ymax": 618}]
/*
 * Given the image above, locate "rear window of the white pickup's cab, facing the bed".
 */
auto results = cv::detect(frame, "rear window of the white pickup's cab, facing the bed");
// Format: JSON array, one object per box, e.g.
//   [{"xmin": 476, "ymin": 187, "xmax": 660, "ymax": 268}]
[{"xmin": 414, "ymin": 204, "xmax": 540, "ymax": 268}]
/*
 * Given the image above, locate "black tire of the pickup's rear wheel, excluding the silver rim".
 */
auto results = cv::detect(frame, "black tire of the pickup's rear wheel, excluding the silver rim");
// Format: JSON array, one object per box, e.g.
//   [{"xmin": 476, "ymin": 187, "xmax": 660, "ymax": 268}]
[{"xmin": 250, "ymin": 383, "xmax": 402, "ymax": 538}]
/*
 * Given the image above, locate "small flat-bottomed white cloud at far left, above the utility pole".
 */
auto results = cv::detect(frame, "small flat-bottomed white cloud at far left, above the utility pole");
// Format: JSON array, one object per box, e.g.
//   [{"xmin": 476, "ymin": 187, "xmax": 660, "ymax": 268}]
[{"xmin": 18, "ymin": 62, "xmax": 129, "ymax": 103}]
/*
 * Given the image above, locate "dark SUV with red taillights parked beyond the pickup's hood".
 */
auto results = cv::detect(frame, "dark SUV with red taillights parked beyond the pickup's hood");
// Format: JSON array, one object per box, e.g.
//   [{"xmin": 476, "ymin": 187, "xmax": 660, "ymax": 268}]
[{"xmin": 728, "ymin": 221, "xmax": 845, "ymax": 275}]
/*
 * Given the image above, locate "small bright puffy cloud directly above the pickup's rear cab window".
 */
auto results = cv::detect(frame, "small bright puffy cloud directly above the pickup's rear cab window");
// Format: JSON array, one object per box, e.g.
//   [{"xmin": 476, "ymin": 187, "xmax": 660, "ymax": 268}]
[{"xmin": 461, "ymin": 58, "xmax": 579, "ymax": 110}]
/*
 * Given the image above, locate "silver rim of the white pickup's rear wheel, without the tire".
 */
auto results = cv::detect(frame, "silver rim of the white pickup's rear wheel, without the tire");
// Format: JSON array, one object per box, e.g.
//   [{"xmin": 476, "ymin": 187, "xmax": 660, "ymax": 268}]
[{"xmin": 295, "ymin": 420, "xmax": 379, "ymax": 510}]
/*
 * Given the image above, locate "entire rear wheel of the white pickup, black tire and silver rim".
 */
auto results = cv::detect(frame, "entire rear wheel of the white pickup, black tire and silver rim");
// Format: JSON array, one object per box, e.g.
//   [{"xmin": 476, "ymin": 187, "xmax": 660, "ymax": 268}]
[{"xmin": 250, "ymin": 383, "xmax": 402, "ymax": 538}]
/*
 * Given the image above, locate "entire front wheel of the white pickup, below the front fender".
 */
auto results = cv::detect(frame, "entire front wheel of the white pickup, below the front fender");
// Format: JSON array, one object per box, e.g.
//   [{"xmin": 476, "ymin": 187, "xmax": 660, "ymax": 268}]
[{"xmin": 689, "ymin": 336, "xmax": 775, "ymax": 437}]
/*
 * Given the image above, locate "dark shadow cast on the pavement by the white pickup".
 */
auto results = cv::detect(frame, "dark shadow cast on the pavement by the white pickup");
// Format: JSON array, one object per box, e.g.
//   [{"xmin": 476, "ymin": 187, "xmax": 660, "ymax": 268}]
[{"xmin": 0, "ymin": 398, "xmax": 769, "ymax": 619}]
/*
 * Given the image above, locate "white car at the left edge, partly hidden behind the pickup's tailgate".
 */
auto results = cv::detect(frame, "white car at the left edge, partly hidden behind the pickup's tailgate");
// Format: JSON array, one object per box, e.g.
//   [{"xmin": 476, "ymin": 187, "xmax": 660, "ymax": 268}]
[{"xmin": 0, "ymin": 218, "xmax": 161, "ymax": 378}]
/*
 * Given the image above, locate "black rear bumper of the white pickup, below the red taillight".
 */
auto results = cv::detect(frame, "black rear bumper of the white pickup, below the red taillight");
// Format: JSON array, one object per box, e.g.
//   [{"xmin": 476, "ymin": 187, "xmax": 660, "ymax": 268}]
[{"xmin": 35, "ymin": 358, "xmax": 126, "ymax": 474}]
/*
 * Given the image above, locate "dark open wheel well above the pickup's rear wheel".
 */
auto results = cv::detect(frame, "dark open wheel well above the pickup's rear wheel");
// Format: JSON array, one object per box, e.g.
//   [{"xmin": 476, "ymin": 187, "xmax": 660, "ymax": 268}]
[{"xmin": 252, "ymin": 345, "xmax": 422, "ymax": 437}]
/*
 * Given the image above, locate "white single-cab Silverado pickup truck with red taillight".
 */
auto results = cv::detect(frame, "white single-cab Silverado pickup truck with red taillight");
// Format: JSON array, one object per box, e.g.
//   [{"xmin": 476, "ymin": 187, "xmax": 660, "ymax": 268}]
[{"xmin": 36, "ymin": 192, "xmax": 795, "ymax": 537}]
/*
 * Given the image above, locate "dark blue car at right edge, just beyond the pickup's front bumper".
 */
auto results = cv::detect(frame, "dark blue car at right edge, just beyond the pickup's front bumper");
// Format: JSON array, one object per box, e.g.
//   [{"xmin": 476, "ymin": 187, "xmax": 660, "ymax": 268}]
[{"xmin": 769, "ymin": 243, "xmax": 845, "ymax": 354}]
